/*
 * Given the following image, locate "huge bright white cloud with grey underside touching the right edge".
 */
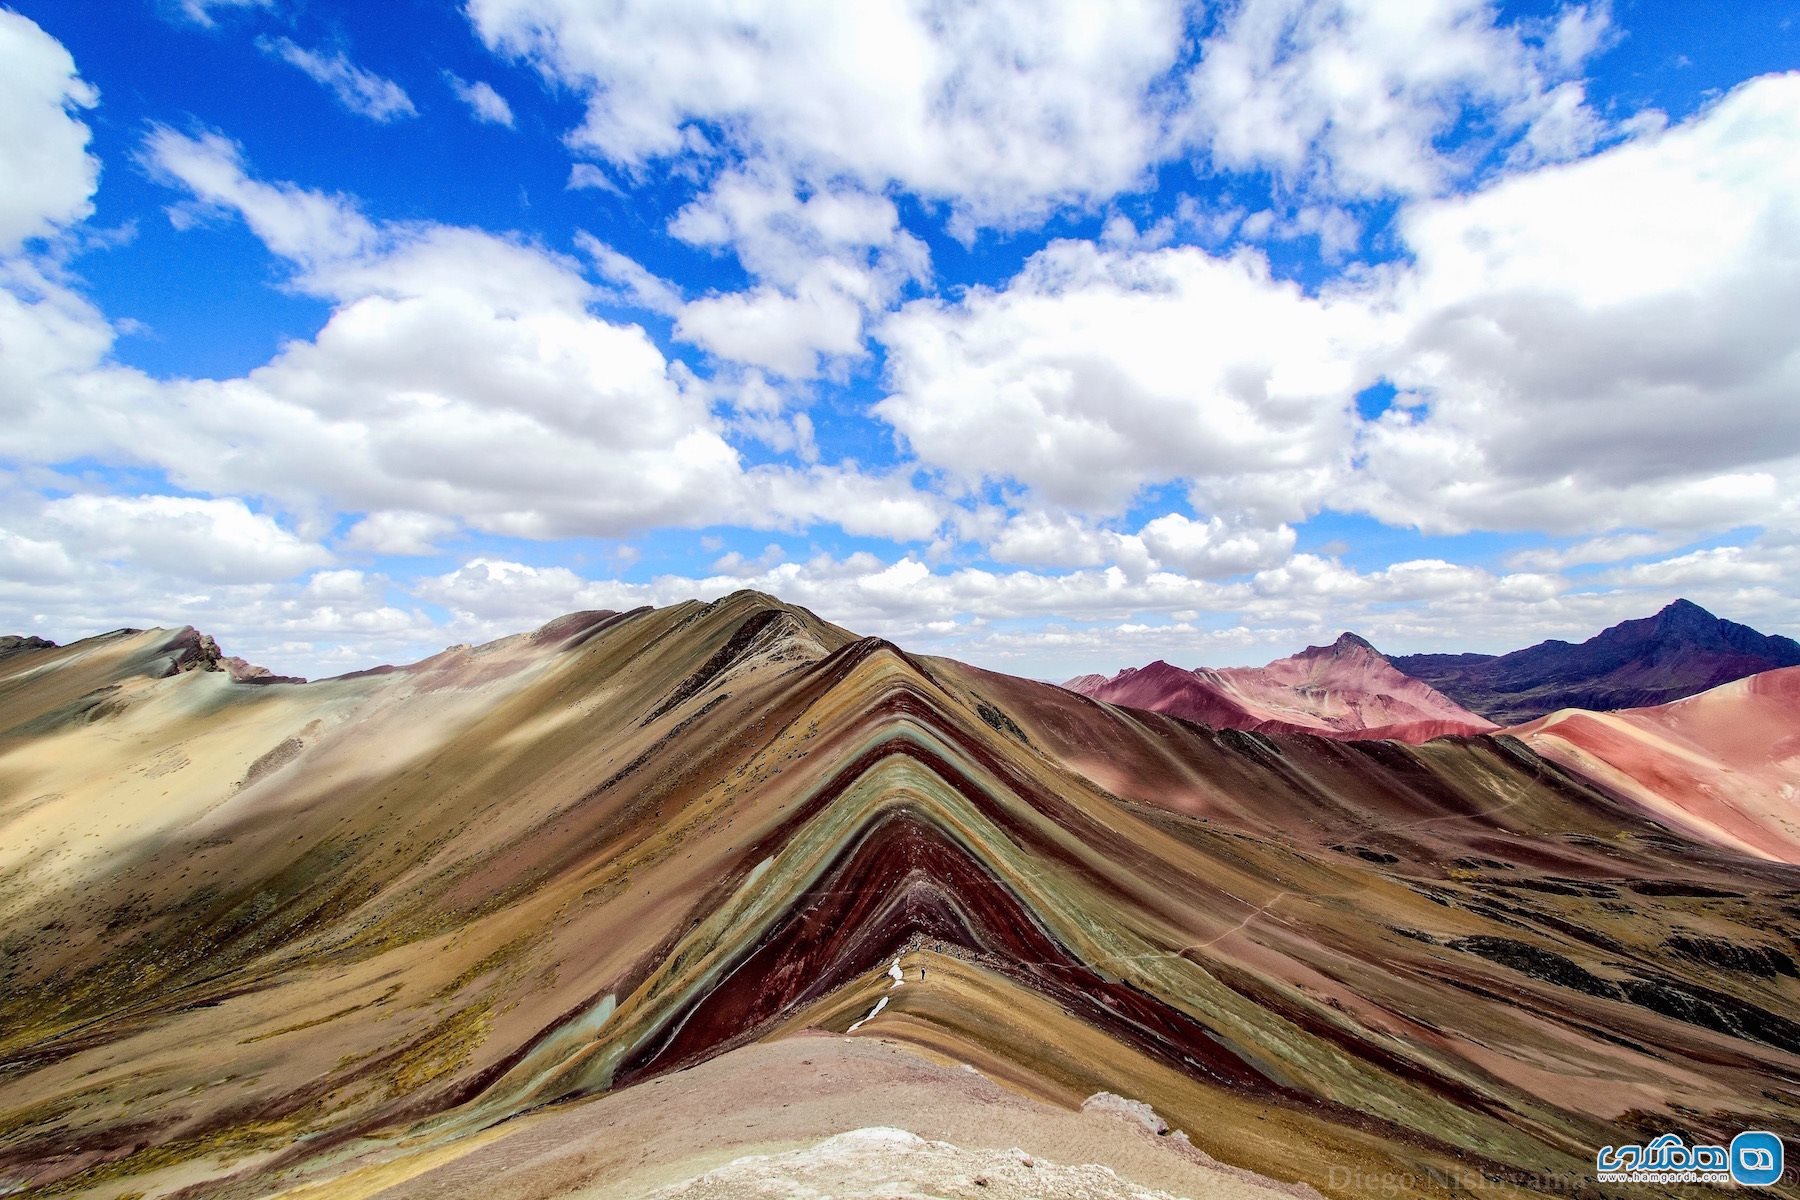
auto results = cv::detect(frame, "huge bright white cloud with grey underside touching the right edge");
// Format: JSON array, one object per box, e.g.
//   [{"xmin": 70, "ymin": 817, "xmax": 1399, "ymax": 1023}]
[{"xmin": 1363, "ymin": 76, "xmax": 1800, "ymax": 533}]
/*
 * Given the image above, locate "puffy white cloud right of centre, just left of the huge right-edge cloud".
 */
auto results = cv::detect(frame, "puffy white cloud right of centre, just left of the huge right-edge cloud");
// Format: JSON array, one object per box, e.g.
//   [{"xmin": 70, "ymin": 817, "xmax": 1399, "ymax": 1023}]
[{"xmin": 875, "ymin": 241, "xmax": 1381, "ymax": 529}]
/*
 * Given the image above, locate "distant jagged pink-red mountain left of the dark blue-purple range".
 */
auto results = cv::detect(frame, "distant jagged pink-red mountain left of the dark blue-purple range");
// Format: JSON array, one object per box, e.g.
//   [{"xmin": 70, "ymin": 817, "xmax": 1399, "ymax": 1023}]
[{"xmin": 1064, "ymin": 633, "xmax": 1496, "ymax": 743}]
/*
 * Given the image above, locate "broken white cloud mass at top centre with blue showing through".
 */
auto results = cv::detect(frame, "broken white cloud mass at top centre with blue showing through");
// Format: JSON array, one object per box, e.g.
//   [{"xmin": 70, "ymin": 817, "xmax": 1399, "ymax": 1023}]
[{"xmin": 468, "ymin": 0, "xmax": 1184, "ymax": 368}]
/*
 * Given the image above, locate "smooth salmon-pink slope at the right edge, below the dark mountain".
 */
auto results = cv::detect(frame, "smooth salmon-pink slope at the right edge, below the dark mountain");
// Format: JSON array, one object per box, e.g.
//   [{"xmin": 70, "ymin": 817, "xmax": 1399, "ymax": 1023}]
[{"xmin": 1507, "ymin": 667, "xmax": 1800, "ymax": 865}]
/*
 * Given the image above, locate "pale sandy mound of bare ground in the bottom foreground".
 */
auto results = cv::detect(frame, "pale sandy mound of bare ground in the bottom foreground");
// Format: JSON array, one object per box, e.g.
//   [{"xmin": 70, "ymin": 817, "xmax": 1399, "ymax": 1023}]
[{"xmin": 262, "ymin": 1033, "xmax": 1318, "ymax": 1200}]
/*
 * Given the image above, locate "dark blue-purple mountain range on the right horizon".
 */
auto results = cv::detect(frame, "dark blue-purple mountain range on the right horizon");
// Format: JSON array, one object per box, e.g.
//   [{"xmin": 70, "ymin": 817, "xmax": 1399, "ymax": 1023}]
[{"xmin": 1391, "ymin": 599, "xmax": 1800, "ymax": 725}]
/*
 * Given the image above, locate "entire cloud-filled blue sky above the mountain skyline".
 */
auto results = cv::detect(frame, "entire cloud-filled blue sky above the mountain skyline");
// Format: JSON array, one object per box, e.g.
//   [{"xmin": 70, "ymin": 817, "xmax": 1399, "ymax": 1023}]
[{"xmin": 0, "ymin": 0, "xmax": 1800, "ymax": 678}]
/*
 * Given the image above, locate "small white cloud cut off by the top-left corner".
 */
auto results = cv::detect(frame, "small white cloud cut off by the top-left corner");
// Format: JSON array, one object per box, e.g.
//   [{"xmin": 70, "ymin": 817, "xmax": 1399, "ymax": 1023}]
[{"xmin": 0, "ymin": 9, "xmax": 101, "ymax": 255}]
